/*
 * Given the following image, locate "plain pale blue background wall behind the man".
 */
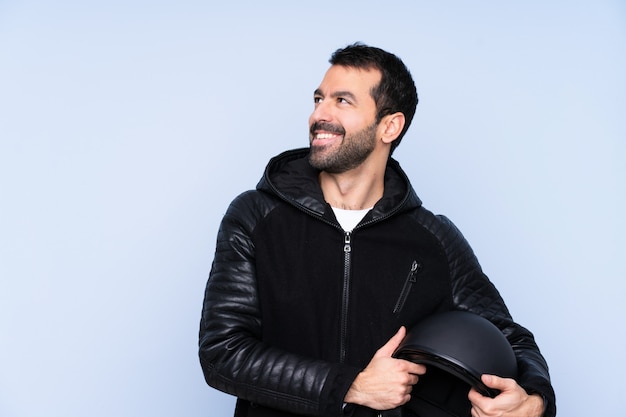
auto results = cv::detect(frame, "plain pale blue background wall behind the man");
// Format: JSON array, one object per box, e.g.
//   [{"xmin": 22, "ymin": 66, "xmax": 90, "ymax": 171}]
[{"xmin": 0, "ymin": 0, "xmax": 626, "ymax": 417}]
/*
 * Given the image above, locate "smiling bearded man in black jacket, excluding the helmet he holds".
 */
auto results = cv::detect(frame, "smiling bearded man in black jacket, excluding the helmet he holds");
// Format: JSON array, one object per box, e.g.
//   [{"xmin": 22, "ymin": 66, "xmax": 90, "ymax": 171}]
[{"xmin": 200, "ymin": 44, "xmax": 556, "ymax": 417}]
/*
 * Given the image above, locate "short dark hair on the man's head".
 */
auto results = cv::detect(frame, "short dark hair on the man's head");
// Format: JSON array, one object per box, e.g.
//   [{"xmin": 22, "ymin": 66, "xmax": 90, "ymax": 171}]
[{"xmin": 329, "ymin": 42, "xmax": 418, "ymax": 152}]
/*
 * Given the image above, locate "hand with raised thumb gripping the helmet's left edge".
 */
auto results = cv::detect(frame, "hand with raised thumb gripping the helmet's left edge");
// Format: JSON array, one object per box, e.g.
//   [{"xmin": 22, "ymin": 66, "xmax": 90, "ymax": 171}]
[{"xmin": 344, "ymin": 327, "xmax": 426, "ymax": 410}]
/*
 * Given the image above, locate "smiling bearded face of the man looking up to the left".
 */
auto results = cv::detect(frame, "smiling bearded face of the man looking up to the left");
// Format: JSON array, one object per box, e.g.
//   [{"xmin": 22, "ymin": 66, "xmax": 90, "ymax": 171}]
[{"xmin": 309, "ymin": 65, "xmax": 381, "ymax": 173}]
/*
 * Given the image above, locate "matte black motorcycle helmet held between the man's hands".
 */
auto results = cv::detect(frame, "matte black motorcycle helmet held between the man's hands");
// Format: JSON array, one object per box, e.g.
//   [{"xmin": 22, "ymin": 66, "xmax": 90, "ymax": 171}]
[{"xmin": 393, "ymin": 311, "xmax": 517, "ymax": 417}]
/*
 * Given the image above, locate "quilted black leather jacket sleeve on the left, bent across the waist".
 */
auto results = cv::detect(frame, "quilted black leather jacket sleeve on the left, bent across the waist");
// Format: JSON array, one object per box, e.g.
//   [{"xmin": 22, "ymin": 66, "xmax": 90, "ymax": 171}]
[{"xmin": 199, "ymin": 192, "xmax": 360, "ymax": 416}]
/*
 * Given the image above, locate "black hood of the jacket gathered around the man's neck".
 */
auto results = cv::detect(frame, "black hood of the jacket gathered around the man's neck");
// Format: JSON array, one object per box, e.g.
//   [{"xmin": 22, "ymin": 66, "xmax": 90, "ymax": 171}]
[{"xmin": 257, "ymin": 148, "xmax": 422, "ymax": 221}]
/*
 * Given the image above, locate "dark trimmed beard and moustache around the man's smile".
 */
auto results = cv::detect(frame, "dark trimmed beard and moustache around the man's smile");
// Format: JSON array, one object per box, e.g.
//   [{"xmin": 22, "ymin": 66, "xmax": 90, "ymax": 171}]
[{"xmin": 309, "ymin": 122, "xmax": 378, "ymax": 174}]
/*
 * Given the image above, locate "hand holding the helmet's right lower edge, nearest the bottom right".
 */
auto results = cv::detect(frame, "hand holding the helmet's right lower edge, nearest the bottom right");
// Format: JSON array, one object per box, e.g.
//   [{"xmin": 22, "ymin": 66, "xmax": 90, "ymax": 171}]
[{"xmin": 468, "ymin": 375, "xmax": 544, "ymax": 417}]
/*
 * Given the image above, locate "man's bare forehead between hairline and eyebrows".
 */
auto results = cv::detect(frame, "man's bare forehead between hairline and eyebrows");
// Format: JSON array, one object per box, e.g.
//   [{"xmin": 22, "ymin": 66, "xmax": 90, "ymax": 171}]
[{"xmin": 317, "ymin": 65, "xmax": 381, "ymax": 95}]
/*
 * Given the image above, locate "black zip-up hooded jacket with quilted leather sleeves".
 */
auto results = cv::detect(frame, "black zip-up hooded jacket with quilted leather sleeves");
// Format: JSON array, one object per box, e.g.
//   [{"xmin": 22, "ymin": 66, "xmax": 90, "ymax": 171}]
[{"xmin": 200, "ymin": 149, "xmax": 555, "ymax": 417}]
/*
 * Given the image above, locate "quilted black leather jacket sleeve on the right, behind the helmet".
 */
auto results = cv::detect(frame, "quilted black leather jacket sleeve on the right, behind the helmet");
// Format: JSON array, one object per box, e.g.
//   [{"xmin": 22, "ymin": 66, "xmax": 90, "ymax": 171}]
[{"xmin": 430, "ymin": 216, "xmax": 556, "ymax": 417}]
